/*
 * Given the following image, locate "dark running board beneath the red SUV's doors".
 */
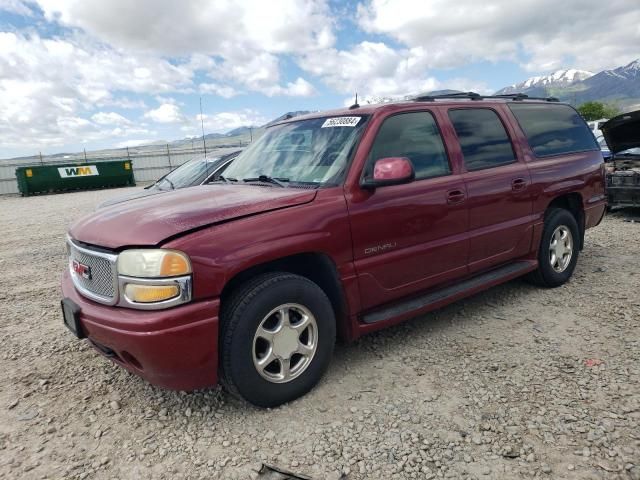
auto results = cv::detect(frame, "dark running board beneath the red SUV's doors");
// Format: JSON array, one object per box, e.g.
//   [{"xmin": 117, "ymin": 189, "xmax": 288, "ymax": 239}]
[{"xmin": 362, "ymin": 261, "xmax": 532, "ymax": 324}]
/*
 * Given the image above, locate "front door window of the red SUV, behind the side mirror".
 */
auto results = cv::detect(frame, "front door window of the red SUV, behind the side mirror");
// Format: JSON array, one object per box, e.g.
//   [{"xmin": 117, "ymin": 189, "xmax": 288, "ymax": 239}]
[{"xmin": 367, "ymin": 112, "xmax": 451, "ymax": 180}]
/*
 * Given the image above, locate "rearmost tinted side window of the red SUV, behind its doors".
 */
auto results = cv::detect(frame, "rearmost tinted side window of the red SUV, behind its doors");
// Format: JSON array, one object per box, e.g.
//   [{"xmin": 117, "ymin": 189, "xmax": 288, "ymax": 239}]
[{"xmin": 509, "ymin": 103, "xmax": 598, "ymax": 157}]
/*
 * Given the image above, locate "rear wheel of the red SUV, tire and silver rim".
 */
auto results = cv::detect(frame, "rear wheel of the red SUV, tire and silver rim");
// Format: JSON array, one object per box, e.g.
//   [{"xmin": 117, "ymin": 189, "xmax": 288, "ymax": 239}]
[{"xmin": 528, "ymin": 208, "xmax": 580, "ymax": 288}]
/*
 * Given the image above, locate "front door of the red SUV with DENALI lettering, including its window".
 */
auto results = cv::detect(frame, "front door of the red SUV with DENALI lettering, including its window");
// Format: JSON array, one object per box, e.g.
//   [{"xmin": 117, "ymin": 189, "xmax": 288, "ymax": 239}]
[{"xmin": 347, "ymin": 111, "xmax": 468, "ymax": 309}]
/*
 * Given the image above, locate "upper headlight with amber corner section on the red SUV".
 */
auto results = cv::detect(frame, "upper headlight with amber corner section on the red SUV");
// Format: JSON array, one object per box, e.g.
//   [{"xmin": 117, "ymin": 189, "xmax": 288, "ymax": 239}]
[{"xmin": 118, "ymin": 249, "xmax": 191, "ymax": 278}]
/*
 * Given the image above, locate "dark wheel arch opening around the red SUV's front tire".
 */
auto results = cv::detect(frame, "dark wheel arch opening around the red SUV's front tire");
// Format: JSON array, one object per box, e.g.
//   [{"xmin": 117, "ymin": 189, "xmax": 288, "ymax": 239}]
[{"xmin": 220, "ymin": 252, "xmax": 349, "ymax": 340}]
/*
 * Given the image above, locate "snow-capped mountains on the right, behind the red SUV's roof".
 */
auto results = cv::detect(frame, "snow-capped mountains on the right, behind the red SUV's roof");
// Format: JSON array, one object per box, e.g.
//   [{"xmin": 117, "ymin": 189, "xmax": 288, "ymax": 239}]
[{"xmin": 496, "ymin": 59, "xmax": 640, "ymax": 110}]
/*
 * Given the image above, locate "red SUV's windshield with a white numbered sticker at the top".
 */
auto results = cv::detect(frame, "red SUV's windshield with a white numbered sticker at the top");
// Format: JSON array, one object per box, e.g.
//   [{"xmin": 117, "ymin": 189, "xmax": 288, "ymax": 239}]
[{"xmin": 224, "ymin": 115, "xmax": 367, "ymax": 186}]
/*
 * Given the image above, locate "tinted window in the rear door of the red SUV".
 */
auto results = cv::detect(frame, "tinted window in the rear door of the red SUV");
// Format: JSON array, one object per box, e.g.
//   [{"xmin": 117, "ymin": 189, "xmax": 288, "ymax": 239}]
[{"xmin": 449, "ymin": 108, "xmax": 516, "ymax": 171}]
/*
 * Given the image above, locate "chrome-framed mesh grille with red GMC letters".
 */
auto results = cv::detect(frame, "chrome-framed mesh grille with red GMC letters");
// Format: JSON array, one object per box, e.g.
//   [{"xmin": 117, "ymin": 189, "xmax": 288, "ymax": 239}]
[{"xmin": 69, "ymin": 241, "xmax": 117, "ymax": 303}]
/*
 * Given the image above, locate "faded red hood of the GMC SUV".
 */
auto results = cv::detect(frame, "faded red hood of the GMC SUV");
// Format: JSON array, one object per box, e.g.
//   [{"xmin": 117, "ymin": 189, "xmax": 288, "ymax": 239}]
[{"xmin": 69, "ymin": 184, "xmax": 316, "ymax": 249}]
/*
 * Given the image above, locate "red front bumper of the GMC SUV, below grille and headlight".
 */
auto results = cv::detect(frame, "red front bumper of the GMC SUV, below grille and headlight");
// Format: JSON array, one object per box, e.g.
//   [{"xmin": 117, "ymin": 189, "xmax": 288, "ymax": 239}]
[{"xmin": 62, "ymin": 270, "xmax": 220, "ymax": 390}]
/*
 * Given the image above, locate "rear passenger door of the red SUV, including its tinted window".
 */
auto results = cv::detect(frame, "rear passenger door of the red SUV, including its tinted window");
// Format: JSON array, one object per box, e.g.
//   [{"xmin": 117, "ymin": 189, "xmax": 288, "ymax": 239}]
[{"xmin": 448, "ymin": 106, "xmax": 533, "ymax": 273}]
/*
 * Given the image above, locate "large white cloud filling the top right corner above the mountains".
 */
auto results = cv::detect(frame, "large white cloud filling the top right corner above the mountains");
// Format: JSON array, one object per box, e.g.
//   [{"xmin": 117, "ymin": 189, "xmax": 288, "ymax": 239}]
[{"xmin": 358, "ymin": 0, "xmax": 640, "ymax": 71}]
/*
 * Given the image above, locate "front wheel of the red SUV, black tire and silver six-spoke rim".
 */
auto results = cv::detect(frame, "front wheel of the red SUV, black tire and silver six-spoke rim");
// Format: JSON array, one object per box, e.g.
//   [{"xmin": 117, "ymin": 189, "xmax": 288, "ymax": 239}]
[{"xmin": 220, "ymin": 272, "xmax": 336, "ymax": 407}]
